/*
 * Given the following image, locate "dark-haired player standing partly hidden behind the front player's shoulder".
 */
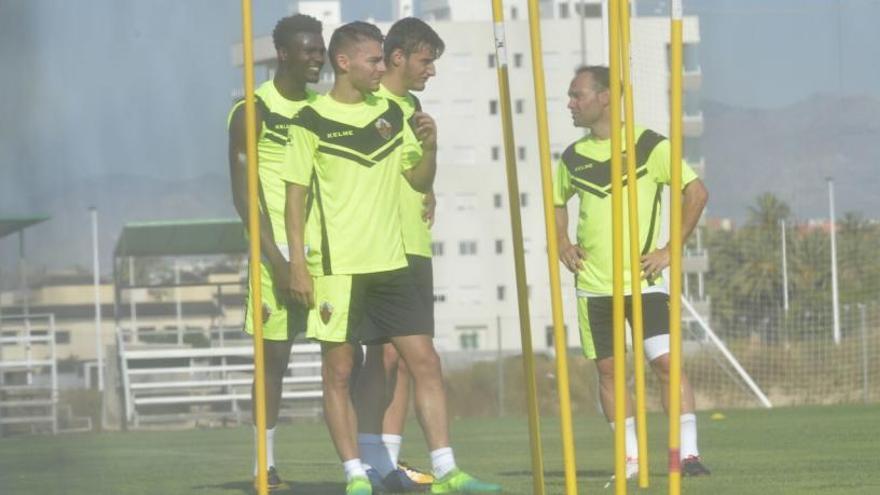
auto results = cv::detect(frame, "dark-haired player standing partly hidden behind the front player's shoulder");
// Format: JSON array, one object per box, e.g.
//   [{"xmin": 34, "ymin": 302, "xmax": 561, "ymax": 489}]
[{"xmin": 354, "ymin": 17, "xmax": 445, "ymax": 493}]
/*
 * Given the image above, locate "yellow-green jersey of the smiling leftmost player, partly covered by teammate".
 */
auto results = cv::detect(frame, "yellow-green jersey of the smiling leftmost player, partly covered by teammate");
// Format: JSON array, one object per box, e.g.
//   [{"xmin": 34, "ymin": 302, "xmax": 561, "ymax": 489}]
[{"xmin": 227, "ymin": 79, "xmax": 318, "ymax": 246}]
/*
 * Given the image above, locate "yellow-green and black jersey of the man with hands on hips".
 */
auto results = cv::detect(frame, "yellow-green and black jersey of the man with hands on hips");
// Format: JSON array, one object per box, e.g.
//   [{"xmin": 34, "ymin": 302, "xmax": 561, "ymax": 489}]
[{"xmin": 553, "ymin": 127, "xmax": 697, "ymax": 296}]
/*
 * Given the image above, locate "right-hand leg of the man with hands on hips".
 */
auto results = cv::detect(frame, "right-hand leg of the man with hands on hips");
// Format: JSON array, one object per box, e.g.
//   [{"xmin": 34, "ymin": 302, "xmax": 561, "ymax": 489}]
[{"xmin": 642, "ymin": 293, "xmax": 709, "ymax": 476}]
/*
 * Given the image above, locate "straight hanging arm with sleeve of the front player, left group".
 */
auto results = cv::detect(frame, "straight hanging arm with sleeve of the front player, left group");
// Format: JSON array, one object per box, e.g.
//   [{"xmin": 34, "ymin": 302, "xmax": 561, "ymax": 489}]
[{"xmin": 281, "ymin": 121, "xmax": 317, "ymax": 308}]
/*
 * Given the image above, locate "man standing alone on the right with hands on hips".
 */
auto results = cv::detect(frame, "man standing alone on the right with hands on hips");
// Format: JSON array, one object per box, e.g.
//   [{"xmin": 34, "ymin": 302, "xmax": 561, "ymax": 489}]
[{"xmin": 554, "ymin": 66, "xmax": 709, "ymax": 478}]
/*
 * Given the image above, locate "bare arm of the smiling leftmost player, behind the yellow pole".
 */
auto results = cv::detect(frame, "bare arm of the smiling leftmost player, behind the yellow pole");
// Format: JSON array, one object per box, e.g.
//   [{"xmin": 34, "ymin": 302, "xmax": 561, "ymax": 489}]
[{"xmin": 229, "ymin": 104, "xmax": 288, "ymax": 297}]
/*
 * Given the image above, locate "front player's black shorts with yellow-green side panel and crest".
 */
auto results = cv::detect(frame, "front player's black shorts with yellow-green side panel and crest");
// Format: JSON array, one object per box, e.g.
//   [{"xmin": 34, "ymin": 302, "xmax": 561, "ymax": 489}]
[{"xmin": 306, "ymin": 267, "xmax": 434, "ymax": 344}]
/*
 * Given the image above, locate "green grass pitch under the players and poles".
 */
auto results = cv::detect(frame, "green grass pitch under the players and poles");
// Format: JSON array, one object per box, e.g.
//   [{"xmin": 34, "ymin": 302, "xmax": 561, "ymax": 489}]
[{"xmin": 0, "ymin": 405, "xmax": 880, "ymax": 495}]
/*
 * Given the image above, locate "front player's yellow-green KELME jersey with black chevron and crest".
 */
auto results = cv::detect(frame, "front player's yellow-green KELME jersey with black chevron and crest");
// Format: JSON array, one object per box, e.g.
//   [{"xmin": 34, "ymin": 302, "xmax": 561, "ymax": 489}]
[{"xmin": 282, "ymin": 95, "xmax": 421, "ymax": 276}]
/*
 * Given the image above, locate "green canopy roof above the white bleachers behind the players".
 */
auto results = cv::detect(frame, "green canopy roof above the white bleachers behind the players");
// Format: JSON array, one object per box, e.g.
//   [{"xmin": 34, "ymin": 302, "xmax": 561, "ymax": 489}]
[{"xmin": 114, "ymin": 218, "xmax": 248, "ymax": 258}]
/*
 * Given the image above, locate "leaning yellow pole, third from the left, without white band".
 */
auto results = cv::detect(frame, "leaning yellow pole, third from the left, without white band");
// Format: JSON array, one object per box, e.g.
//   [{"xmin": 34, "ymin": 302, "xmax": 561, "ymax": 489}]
[{"xmin": 529, "ymin": 0, "xmax": 577, "ymax": 495}]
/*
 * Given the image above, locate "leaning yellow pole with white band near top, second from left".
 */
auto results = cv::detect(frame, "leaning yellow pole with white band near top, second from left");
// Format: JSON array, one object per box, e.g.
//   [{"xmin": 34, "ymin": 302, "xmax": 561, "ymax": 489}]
[{"xmin": 492, "ymin": 0, "xmax": 544, "ymax": 495}]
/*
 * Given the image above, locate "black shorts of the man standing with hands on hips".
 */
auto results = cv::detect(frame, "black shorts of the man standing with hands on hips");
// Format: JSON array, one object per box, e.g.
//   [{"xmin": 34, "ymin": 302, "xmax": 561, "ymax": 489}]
[{"xmin": 578, "ymin": 292, "xmax": 669, "ymax": 359}]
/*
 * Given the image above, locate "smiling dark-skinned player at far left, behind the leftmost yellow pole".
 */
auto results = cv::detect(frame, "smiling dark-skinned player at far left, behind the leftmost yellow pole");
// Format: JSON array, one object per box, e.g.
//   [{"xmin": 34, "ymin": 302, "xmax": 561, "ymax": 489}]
[{"xmin": 229, "ymin": 14, "xmax": 325, "ymax": 489}]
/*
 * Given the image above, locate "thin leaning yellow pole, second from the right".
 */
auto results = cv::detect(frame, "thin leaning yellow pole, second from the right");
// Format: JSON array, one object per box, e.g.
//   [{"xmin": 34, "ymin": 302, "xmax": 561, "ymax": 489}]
[{"xmin": 620, "ymin": 0, "xmax": 648, "ymax": 488}]
